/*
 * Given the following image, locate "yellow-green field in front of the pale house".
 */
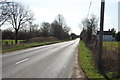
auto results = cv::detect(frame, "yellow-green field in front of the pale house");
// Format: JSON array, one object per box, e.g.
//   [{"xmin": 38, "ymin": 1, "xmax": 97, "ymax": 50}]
[{"xmin": 103, "ymin": 42, "xmax": 120, "ymax": 51}]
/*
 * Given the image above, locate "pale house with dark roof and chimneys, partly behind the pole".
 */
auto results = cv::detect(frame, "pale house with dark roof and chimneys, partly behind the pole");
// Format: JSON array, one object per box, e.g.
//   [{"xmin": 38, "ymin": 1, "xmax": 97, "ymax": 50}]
[{"xmin": 97, "ymin": 30, "xmax": 115, "ymax": 41}]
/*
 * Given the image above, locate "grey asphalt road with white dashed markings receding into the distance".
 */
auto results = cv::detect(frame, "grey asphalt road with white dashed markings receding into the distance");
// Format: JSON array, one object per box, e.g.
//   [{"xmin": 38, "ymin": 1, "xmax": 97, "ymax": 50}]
[{"xmin": 2, "ymin": 39, "xmax": 79, "ymax": 78}]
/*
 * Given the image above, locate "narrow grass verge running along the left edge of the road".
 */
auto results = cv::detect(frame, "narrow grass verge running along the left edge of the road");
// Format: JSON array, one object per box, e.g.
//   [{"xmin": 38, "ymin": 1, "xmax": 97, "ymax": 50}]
[{"xmin": 2, "ymin": 41, "xmax": 60, "ymax": 53}]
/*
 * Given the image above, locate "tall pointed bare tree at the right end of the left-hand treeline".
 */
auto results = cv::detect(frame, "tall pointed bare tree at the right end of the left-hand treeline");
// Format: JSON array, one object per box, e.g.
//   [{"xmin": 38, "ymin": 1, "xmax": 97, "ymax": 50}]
[{"xmin": 51, "ymin": 14, "xmax": 70, "ymax": 39}]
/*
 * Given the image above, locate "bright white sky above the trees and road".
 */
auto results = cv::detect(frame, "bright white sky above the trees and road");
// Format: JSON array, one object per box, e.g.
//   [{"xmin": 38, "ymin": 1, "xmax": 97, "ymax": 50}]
[{"xmin": 1, "ymin": 0, "xmax": 119, "ymax": 34}]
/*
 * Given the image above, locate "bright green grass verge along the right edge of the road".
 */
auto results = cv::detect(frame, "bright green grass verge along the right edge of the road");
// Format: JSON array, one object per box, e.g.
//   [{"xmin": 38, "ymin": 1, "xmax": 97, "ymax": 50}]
[{"xmin": 79, "ymin": 41, "xmax": 105, "ymax": 80}]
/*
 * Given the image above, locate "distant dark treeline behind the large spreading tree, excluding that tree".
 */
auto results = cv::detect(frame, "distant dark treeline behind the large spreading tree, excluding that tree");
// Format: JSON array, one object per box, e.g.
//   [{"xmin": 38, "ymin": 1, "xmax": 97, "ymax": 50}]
[{"xmin": 2, "ymin": 14, "xmax": 70, "ymax": 40}]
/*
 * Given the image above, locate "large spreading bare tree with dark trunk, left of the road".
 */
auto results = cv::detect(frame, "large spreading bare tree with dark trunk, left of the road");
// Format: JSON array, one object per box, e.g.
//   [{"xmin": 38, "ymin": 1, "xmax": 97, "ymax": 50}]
[{"xmin": 7, "ymin": 2, "xmax": 33, "ymax": 44}]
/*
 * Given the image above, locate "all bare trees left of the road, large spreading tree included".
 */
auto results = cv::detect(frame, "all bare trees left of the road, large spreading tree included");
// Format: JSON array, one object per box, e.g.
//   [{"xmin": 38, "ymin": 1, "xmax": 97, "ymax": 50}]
[{"xmin": 0, "ymin": 0, "xmax": 77, "ymax": 44}]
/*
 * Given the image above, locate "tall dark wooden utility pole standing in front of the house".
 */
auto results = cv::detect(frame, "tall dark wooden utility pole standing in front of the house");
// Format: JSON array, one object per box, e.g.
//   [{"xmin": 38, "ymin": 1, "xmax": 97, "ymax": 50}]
[{"xmin": 98, "ymin": 0, "xmax": 105, "ymax": 73}]
